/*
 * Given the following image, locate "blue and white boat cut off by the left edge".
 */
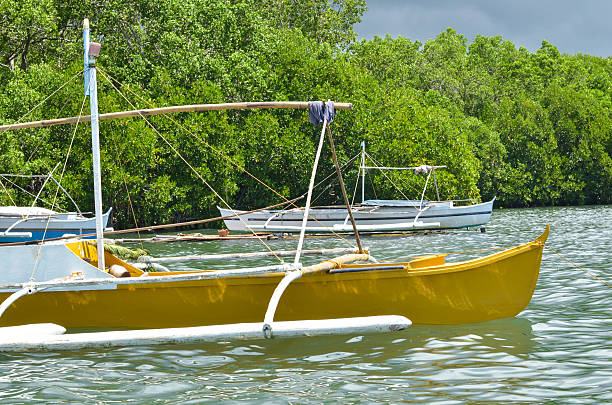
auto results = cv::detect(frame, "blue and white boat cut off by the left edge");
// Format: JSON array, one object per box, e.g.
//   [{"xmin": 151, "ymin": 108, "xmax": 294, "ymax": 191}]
[{"xmin": 0, "ymin": 172, "xmax": 112, "ymax": 243}]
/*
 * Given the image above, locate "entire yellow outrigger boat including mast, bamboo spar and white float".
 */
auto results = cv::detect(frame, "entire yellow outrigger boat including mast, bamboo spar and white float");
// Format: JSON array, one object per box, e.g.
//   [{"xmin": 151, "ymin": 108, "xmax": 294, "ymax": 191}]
[{"xmin": 0, "ymin": 19, "xmax": 549, "ymax": 351}]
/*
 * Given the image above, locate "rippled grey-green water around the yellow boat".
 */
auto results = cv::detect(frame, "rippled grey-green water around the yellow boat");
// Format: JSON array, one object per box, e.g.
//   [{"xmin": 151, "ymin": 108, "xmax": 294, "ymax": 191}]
[{"xmin": 0, "ymin": 206, "xmax": 612, "ymax": 404}]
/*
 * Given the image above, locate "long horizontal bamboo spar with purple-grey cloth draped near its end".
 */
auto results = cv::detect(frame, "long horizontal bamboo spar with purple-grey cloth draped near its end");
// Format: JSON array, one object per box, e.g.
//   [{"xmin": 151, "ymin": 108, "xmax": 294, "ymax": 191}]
[{"xmin": 0, "ymin": 101, "xmax": 353, "ymax": 131}]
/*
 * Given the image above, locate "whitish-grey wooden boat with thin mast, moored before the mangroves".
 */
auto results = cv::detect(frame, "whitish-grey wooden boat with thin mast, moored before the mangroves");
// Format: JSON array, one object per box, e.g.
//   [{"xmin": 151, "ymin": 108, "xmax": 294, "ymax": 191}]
[{"xmin": 217, "ymin": 142, "xmax": 495, "ymax": 233}]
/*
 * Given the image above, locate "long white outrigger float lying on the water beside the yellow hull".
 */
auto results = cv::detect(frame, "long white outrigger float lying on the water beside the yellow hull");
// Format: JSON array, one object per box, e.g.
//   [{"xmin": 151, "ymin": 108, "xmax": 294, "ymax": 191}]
[{"xmin": 0, "ymin": 315, "xmax": 412, "ymax": 352}]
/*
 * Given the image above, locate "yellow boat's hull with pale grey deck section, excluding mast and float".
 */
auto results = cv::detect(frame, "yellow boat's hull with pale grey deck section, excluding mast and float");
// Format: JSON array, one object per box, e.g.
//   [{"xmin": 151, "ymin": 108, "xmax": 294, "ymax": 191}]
[{"xmin": 0, "ymin": 224, "xmax": 548, "ymax": 328}]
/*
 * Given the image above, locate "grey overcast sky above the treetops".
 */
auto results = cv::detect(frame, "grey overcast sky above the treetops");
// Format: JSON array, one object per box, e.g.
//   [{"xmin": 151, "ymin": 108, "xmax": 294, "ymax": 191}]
[{"xmin": 355, "ymin": 0, "xmax": 612, "ymax": 57}]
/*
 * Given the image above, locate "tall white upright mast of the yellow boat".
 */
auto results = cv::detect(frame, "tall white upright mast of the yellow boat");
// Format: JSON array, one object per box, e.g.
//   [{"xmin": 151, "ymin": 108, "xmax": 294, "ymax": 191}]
[{"xmin": 83, "ymin": 18, "xmax": 104, "ymax": 271}]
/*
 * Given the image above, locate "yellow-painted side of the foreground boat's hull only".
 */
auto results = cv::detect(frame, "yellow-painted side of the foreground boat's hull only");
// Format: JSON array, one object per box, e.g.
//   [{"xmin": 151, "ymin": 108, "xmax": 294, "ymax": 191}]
[{"xmin": 0, "ymin": 229, "xmax": 548, "ymax": 328}]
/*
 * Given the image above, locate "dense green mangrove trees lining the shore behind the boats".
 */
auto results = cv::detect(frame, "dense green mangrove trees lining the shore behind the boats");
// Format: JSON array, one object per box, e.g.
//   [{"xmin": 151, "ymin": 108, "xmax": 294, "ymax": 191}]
[{"xmin": 0, "ymin": 0, "xmax": 612, "ymax": 226}]
